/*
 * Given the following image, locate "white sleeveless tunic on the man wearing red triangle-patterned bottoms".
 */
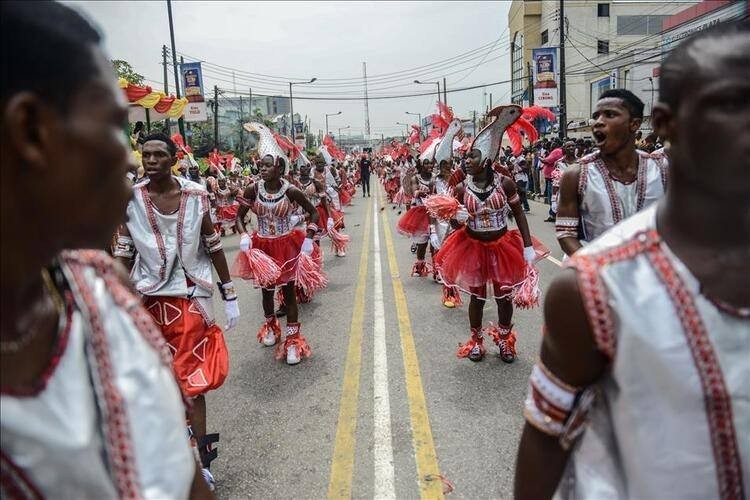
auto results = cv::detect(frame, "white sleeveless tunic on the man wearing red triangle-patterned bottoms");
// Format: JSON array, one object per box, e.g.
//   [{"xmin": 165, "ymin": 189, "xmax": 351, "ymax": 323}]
[{"xmin": 127, "ymin": 177, "xmax": 213, "ymax": 311}]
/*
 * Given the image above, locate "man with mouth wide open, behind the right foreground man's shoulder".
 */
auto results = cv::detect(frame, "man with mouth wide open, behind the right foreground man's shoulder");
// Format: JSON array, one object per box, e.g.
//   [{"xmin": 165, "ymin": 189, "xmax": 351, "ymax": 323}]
[{"xmin": 555, "ymin": 89, "xmax": 667, "ymax": 255}]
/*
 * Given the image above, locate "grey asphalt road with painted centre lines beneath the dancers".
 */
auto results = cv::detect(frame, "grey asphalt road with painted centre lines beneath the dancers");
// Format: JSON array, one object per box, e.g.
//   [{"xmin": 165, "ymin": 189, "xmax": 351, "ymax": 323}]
[{"xmin": 208, "ymin": 186, "xmax": 561, "ymax": 499}]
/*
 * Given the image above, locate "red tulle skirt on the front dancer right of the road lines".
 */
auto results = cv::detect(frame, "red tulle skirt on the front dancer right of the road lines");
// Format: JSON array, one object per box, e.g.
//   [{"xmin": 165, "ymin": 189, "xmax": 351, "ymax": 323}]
[{"xmin": 435, "ymin": 227, "xmax": 549, "ymax": 299}]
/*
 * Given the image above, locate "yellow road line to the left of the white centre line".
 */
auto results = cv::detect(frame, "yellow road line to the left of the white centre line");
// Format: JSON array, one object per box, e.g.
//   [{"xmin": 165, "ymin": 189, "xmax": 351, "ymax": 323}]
[{"xmin": 328, "ymin": 203, "xmax": 372, "ymax": 498}]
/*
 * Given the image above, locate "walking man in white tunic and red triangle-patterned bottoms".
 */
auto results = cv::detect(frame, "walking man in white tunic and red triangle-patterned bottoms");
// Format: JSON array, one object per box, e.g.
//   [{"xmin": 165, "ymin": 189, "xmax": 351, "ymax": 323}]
[{"xmin": 114, "ymin": 133, "xmax": 240, "ymax": 485}]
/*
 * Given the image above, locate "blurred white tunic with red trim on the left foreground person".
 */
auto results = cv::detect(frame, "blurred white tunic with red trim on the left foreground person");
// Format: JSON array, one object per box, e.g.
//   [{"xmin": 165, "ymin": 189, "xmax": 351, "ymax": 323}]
[{"xmin": 0, "ymin": 250, "xmax": 195, "ymax": 499}]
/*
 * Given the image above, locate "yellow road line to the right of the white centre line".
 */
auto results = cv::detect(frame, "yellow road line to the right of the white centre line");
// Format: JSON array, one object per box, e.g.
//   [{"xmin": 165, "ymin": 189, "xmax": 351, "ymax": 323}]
[{"xmin": 378, "ymin": 189, "xmax": 443, "ymax": 499}]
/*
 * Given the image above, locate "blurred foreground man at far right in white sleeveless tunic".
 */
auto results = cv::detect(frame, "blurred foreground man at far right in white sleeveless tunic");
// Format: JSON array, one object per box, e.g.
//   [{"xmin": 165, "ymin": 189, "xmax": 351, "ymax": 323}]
[{"xmin": 515, "ymin": 21, "xmax": 750, "ymax": 500}]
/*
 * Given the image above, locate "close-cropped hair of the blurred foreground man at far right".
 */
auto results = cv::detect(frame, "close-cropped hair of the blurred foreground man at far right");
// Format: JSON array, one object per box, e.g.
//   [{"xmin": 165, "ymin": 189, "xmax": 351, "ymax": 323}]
[{"xmin": 659, "ymin": 20, "xmax": 750, "ymax": 108}]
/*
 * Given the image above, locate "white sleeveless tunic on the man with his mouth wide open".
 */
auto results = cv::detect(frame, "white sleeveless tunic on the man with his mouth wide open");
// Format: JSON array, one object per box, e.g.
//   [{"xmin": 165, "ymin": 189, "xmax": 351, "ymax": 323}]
[{"xmin": 578, "ymin": 151, "xmax": 667, "ymax": 242}]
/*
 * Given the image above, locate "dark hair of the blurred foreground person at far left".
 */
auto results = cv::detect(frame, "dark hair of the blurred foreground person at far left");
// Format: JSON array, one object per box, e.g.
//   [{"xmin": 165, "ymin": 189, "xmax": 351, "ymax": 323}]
[{"xmin": 0, "ymin": 1, "xmax": 101, "ymax": 112}]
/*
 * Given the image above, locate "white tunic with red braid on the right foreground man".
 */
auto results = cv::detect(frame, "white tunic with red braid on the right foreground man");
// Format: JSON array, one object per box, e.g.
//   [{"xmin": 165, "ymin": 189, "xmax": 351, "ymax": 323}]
[{"xmin": 558, "ymin": 204, "xmax": 750, "ymax": 500}]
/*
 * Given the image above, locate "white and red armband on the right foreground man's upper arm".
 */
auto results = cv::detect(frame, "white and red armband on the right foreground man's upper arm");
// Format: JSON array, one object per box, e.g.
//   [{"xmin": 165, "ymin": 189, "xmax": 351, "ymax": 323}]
[{"xmin": 523, "ymin": 361, "xmax": 594, "ymax": 449}]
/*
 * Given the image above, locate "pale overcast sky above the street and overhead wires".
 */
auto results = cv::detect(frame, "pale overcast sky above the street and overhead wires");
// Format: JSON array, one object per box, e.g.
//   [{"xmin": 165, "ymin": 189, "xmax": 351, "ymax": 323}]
[{"xmin": 66, "ymin": 1, "xmax": 510, "ymax": 139}]
